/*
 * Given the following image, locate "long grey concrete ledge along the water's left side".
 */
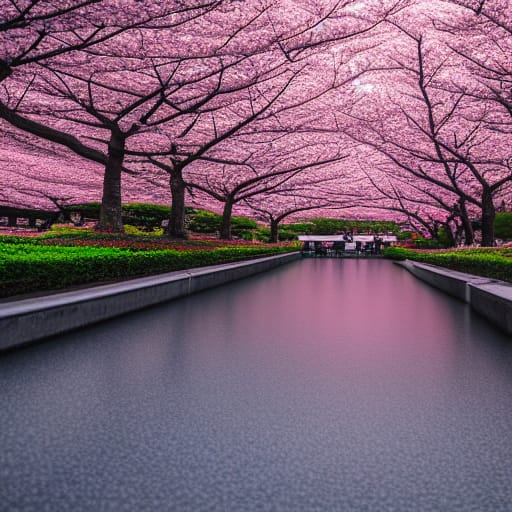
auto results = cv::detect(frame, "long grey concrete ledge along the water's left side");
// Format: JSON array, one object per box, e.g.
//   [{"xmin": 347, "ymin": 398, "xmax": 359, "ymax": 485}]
[{"xmin": 0, "ymin": 253, "xmax": 300, "ymax": 351}]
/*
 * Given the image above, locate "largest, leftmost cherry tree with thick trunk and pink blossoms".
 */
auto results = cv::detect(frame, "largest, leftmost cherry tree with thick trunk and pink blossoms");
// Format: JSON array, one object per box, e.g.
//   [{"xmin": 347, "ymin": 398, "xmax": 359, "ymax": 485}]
[{"xmin": 0, "ymin": 1, "xmax": 228, "ymax": 230}]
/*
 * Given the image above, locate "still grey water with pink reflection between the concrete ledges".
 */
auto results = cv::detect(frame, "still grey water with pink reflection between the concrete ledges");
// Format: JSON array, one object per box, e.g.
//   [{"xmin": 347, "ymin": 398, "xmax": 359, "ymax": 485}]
[{"xmin": 0, "ymin": 259, "xmax": 512, "ymax": 512}]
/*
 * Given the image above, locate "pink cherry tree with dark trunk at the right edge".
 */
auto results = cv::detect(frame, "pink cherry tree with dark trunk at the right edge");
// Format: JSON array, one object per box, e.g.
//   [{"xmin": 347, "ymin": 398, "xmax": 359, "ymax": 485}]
[{"xmin": 344, "ymin": 8, "xmax": 512, "ymax": 245}]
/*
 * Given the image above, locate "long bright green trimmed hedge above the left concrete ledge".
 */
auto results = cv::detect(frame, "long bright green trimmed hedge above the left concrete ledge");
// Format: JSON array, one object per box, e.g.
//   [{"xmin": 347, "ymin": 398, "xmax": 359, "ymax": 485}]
[{"xmin": 0, "ymin": 242, "xmax": 290, "ymax": 297}]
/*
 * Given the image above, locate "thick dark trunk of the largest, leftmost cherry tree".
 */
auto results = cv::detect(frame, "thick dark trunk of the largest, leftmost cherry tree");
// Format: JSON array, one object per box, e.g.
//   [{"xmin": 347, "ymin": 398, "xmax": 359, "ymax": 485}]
[{"xmin": 96, "ymin": 130, "xmax": 125, "ymax": 233}]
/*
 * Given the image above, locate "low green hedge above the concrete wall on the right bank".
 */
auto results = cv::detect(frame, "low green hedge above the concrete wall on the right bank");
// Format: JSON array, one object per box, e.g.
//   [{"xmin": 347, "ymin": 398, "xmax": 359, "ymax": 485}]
[{"xmin": 384, "ymin": 247, "xmax": 512, "ymax": 282}]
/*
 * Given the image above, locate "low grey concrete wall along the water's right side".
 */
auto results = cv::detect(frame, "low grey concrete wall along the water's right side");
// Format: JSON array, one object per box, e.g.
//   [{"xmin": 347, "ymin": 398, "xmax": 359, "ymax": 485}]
[{"xmin": 397, "ymin": 260, "xmax": 512, "ymax": 335}]
